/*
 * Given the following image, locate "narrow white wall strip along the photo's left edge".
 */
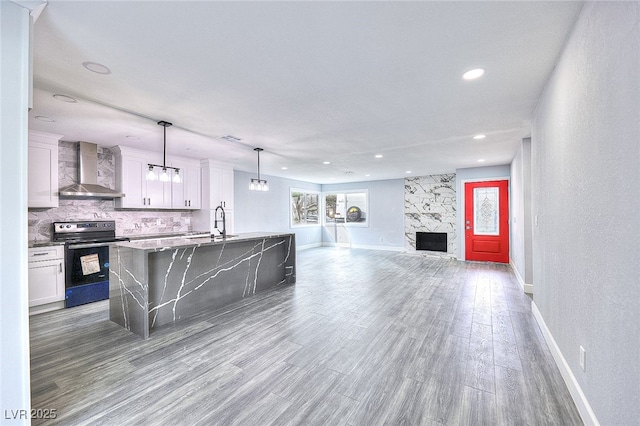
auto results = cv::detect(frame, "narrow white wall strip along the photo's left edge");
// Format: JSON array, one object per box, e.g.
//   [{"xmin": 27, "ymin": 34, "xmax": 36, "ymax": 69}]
[{"xmin": 0, "ymin": 1, "xmax": 31, "ymax": 424}]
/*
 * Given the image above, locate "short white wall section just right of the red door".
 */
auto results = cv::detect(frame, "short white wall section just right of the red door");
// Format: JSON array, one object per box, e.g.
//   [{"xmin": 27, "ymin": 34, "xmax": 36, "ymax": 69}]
[{"xmin": 509, "ymin": 138, "xmax": 533, "ymax": 293}]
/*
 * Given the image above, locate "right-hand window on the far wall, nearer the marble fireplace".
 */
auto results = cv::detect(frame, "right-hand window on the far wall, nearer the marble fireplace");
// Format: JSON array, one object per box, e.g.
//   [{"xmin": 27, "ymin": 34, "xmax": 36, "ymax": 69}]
[{"xmin": 324, "ymin": 190, "xmax": 369, "ymax": 226}]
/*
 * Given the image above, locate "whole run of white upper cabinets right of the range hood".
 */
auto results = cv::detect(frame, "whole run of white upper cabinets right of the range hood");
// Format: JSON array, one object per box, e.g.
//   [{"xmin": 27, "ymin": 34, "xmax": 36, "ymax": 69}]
[{"xmin": 113, "ymin": 146, "xmax": 201, "ymax": 210}]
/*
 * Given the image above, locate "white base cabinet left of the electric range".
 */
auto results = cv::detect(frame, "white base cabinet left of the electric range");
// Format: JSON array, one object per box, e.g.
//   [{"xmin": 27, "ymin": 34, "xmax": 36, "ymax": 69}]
[{"xmin": 29, "ymin": 246, "xmax": 65, "ymax": 314}]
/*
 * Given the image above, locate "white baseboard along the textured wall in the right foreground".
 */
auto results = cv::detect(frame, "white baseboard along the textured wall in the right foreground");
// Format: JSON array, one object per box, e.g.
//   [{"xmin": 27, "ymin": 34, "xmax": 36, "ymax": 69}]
[{"xmin": 531, "ymin": 301, "xmax": 600, "ymax": 426}]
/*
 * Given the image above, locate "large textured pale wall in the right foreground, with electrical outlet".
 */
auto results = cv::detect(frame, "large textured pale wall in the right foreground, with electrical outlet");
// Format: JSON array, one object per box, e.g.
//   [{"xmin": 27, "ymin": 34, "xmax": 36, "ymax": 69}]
[{"xmin": 532, "ymin": 2, "xmax": 640, "ymax": 425}]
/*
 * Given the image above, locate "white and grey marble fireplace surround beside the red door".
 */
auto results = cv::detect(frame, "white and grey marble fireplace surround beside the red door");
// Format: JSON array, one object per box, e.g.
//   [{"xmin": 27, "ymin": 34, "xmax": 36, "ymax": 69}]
[{"xmin": 404, "ymin": 173, "xmax": 458, "ymax": 258}]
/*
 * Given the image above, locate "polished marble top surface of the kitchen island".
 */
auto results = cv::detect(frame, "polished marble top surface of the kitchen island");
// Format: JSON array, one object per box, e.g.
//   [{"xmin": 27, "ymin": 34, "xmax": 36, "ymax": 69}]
[{"xmin": 116, "ymin": 232, "xmax": 290, "ymax": 251}]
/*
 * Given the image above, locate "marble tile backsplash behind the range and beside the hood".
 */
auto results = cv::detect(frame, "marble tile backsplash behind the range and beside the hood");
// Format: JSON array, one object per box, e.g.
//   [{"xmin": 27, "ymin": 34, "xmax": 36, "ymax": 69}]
[{"xmin": 28, "ymin": 141, "xmax": 192, "ymax": 242}]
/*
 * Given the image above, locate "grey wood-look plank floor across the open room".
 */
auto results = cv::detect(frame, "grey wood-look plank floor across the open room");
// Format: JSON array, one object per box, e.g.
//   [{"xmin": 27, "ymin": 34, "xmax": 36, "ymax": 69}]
[{"xmin": 30, "ymin": 248, "xmax": 582, "ymax": 425}]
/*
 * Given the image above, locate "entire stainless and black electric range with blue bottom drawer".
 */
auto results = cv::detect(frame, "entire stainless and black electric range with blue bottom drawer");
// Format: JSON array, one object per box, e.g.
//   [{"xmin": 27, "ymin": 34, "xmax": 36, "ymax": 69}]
[{"xmin": 53, "ymin": 220, "xmax": 129, "ymax": 308}]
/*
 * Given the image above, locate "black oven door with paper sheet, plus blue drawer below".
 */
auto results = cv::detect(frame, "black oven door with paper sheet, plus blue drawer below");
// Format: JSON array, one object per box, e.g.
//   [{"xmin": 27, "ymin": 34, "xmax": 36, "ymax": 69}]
[{"xmin": 65, "ymin": 243, "xmax": 109, "ymax": 308}]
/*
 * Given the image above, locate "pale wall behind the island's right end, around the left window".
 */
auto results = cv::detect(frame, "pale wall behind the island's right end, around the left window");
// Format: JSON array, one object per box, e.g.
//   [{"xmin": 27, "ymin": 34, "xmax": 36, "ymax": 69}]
[{"xmin": 233, "ymin": 170, "xmax": 322, "ymax": 247}]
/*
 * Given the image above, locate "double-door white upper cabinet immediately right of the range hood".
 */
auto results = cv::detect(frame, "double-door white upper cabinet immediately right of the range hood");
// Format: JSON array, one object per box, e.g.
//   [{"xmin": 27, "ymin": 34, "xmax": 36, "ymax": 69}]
[{"xmin": 114, "ymin": 146, "xmax": 172, "ymax": 209}]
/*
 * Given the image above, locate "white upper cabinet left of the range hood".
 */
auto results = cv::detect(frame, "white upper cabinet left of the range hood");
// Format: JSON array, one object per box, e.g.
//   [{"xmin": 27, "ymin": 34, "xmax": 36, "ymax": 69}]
[{"xmin": 28, "ymin": 130, "xmax": 62, "ymax": 207}]
